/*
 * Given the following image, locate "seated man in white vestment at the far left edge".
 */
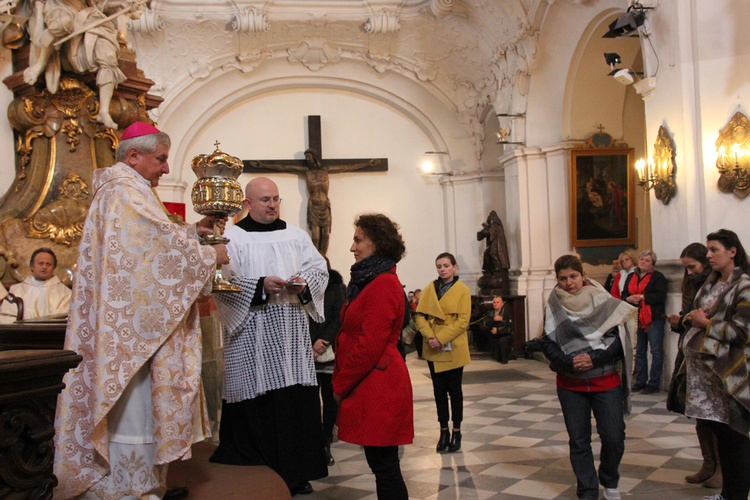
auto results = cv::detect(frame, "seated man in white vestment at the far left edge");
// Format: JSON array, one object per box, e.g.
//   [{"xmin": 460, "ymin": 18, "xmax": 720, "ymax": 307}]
[{"xmin": 0, "ymin": 247, "xmax": 70, "ymax": 322}]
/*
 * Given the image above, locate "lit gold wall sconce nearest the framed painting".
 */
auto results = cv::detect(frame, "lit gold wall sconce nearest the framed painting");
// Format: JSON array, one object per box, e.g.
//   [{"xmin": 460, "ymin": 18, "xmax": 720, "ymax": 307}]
[{"xmin": 635, "ymin": 126, "xmax": 677, "ymax": 205}]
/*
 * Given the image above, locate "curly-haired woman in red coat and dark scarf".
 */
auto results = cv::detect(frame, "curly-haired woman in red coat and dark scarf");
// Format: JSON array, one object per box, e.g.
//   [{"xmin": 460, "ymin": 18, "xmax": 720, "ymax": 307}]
[{"xmin": 333, "ymin": 214, "xmax": 414, "ymax": 500}]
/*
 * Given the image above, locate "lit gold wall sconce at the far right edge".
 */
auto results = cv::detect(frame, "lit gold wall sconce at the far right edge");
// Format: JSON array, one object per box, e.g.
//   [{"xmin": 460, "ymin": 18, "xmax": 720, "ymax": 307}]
[{"xmin": 716, "ymin": 111, "xmax": 750, "ymax": 198}]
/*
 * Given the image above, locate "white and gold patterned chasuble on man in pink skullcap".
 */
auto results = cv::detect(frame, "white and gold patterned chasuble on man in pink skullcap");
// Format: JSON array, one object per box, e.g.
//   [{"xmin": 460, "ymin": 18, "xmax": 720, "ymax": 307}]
[{"xmin": 54, "ymin": 163, "xmax": 216, "ymax": 498}]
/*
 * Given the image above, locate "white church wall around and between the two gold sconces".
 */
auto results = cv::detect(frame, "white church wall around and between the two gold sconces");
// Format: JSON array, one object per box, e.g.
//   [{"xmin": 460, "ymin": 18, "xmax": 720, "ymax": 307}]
[{"xmin": 646, "ymin": 0, "xmax": 750, "ymax": 252}]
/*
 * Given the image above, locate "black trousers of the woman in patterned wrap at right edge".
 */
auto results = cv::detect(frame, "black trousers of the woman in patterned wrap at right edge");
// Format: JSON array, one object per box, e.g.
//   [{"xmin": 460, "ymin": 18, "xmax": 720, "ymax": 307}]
[{"xmin": 702, "ymin": 420, "xmax": 750, "ymax": 500}]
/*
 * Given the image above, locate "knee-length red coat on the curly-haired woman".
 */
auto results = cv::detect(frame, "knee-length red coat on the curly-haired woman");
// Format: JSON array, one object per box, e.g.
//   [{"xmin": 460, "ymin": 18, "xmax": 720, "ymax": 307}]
[{"xmin": 333, "ymin": 272, "xmax": 414, "ymax": 446}]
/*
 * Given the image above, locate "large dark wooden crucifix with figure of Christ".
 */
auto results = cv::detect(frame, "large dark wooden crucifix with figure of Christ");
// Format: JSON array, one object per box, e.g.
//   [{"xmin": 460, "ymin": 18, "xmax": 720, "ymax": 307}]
[{"xmin": 243, "ymin": 115, "xmax": 388, "ymax": 255}]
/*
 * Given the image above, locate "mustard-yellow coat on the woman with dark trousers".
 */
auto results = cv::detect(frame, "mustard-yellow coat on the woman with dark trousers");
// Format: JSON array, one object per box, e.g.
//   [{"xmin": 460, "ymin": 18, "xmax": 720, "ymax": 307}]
[{"xmin": 415, "ymin": 281, "xmax": 471, "ymax": 373}]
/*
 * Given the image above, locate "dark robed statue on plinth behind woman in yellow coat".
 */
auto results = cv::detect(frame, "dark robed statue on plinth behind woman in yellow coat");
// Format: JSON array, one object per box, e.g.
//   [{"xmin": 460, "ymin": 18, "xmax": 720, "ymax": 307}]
[{"xmin": 477, "ymin": 210, "xmax": 510, "ymax": 295}]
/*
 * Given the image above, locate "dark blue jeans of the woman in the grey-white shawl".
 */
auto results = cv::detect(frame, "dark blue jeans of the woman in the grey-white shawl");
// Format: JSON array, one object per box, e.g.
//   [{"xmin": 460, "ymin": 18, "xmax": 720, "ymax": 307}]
[{"xmin": 557, "ymin": 386, "xmax": 625, "ymax": 500}]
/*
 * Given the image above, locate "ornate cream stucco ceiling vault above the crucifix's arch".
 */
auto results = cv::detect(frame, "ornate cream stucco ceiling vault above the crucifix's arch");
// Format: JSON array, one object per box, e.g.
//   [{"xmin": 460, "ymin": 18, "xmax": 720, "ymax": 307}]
[{"xmin": 131, "ymin": 0, "xmax": 549, "ymax": 158}]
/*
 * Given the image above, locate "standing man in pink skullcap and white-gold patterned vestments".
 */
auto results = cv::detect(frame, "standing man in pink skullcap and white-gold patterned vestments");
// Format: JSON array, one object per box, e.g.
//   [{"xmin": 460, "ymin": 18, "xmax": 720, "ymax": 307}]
[{"xmin": 54, "ymin": 122, "xmax": 229, "ymax": 500}]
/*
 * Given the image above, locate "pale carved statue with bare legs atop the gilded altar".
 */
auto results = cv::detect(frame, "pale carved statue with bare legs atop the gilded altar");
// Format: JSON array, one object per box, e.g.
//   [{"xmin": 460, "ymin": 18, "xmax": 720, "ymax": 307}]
[{"xmin": 23, "ymin": 0, "xmax": 148, "ymax": 129}]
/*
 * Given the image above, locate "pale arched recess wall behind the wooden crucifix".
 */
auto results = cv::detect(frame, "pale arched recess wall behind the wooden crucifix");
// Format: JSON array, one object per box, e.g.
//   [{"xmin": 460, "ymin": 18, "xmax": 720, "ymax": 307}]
[{"xmin": 150, "ymin": 58, "xmax": 486, "ymax": 289}]
